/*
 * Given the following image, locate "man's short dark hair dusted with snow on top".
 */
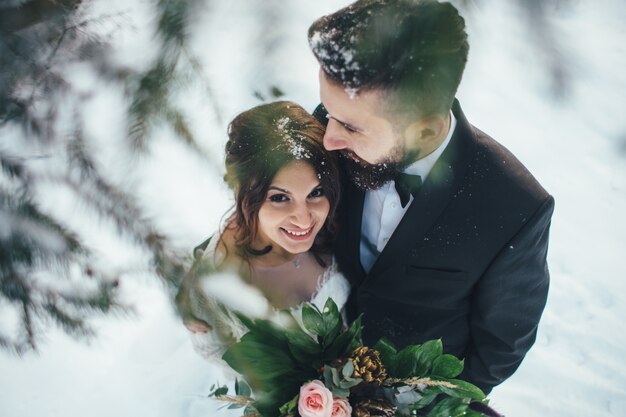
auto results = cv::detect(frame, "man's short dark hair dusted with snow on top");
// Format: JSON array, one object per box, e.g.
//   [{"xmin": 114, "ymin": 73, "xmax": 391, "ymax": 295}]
[{"xmin": 309, "ymin": 0, "xmax": 469, "ymax": 117}]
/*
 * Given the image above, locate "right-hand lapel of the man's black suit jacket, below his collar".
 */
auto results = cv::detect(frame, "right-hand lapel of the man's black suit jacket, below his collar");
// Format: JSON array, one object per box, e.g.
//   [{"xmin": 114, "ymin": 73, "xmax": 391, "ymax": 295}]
[{"xmin": 366, "ymin": 100, "xmax": 474, "ymax": 277}]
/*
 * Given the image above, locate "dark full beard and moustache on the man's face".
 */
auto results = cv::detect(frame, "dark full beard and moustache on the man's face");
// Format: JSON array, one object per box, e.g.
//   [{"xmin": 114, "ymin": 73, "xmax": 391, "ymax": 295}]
[{"xmin": 339, "ymin": 147, "xmax": 420, "ymax": 191}]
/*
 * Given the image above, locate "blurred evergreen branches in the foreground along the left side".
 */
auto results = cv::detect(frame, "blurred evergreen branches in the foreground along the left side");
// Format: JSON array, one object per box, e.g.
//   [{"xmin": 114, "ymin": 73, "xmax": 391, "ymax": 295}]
[{"xmin": 0, "ymin": 0, "xmax": 213, "ymax": 354}]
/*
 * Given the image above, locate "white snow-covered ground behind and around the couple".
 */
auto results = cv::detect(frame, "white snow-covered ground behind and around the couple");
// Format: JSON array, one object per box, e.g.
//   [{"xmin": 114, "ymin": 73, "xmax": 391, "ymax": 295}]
[{"xmin": 0, "ymin": 0, "xmax": 626, "ymax": 417}]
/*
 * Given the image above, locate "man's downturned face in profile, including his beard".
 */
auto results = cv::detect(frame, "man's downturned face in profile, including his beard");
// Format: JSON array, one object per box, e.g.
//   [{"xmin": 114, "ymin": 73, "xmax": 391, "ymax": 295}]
[{"xmin": 319, "ymin": 70, "xmax": 412, "ymax": 190}]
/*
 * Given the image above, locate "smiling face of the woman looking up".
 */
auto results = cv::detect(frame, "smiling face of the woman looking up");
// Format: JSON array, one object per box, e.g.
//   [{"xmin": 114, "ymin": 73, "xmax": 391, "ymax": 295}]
[{"xmin": 258, "ymin": 161, "xmax": 330, "ymax": 254}]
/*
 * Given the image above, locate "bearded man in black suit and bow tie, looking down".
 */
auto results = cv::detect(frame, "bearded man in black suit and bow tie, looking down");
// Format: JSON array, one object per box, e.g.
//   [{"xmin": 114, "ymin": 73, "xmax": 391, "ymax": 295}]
[{"xmin": 309, "ymin": 0, "xmax": 554, "ymax": 393}]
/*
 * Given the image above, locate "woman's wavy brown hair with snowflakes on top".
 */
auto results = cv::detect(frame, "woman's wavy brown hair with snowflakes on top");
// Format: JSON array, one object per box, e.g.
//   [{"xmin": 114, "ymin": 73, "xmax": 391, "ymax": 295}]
[{"xmin": 224, "ymin": 101, "xmax": 340, "ymax": 257}]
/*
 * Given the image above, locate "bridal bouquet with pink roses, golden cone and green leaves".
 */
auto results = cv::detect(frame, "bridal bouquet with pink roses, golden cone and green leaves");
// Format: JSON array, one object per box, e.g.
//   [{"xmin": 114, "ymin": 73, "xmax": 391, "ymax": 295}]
[{"xmin": 210, "ymin": 298, "xmax": 487, "ymax": 417}]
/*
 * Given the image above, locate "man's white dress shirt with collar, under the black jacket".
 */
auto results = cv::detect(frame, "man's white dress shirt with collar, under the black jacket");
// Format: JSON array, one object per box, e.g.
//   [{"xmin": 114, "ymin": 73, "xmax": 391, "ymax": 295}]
[{"xmin": 360, "ymin": 112, "xmax": 456, "ymax": 272}]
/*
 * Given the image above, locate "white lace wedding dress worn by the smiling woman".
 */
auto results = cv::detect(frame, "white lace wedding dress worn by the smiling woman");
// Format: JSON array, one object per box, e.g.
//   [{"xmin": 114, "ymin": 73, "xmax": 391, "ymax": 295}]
[{"xmin": 189, "ymin": 239, "xmax": 350, "ymax": 365}]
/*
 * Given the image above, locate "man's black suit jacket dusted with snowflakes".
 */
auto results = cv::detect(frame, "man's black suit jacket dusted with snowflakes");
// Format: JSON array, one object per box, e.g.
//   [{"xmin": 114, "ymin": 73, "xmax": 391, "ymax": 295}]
[{"xmin": 322, "ymin": 101, "xmax": 554, "ymax": 392}]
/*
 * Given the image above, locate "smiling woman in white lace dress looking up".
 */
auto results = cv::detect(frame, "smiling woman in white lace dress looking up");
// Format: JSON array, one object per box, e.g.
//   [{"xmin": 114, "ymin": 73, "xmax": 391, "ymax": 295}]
[{"xmin": 177, "ymin": 101, "xmax": 350, "ymax": 358}]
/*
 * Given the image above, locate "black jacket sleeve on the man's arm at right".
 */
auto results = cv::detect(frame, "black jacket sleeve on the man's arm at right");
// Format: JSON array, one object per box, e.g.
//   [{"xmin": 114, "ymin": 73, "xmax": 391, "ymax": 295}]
[{"xmin": 461, "ymin": 196, "xmax": 554, "ymax": 392}]
